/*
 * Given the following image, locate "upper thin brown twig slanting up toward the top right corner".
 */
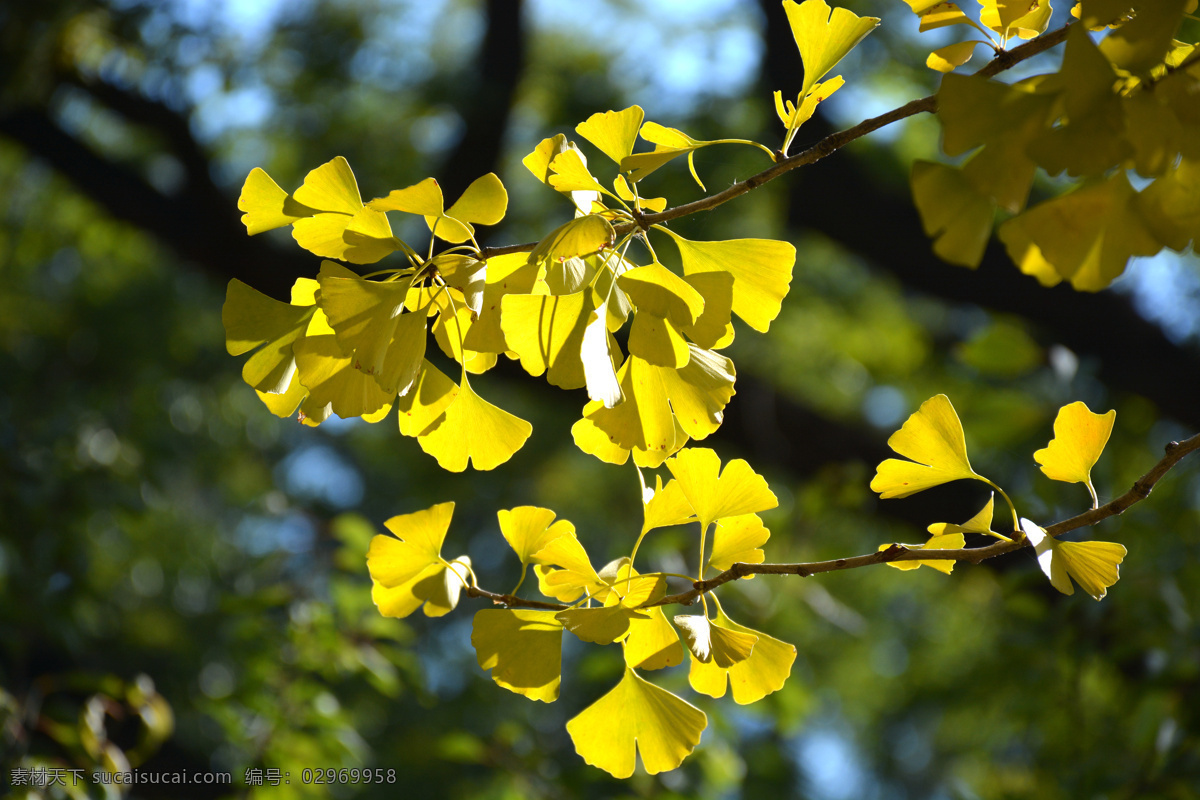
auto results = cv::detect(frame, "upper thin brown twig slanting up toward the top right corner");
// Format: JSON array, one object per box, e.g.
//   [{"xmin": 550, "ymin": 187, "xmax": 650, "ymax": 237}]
[{"xmin": 480, "ymin": 23, "xmax": 1072, "ymax": 260}]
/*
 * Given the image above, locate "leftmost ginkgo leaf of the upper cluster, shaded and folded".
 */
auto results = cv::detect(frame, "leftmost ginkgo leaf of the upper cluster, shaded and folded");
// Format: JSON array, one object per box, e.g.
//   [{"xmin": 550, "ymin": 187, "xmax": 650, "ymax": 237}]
[{"xmin": 221, "ymin": 278, "xmax": 313, "ymax": 393}]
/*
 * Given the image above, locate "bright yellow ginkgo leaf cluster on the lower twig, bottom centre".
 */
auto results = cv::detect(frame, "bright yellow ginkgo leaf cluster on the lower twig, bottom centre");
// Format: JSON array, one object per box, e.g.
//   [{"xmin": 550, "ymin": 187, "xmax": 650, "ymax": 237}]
[{"xmin": 367, "ymin": 449, "xmax": 796, "ymax": 777}]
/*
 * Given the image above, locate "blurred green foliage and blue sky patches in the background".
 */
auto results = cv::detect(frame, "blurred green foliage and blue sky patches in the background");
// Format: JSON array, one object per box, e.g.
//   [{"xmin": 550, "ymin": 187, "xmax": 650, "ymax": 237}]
[{"xmin": 0, "ymin": 0, "xmax": 1200, "ymax": 800}]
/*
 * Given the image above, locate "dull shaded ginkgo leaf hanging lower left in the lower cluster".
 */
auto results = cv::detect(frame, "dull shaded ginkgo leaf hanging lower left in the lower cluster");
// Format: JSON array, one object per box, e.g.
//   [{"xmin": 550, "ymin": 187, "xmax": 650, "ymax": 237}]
[{"xmin": 470, "ymin": 608, "xmax": 563, "ymax": 703}]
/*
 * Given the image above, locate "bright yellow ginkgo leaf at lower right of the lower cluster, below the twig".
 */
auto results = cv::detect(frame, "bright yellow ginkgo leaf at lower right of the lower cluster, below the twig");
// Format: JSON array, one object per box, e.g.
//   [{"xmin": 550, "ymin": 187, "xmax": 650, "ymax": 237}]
[{"xmin": 688, "ymin": 597, "xmax": 796, "ymax": 705}]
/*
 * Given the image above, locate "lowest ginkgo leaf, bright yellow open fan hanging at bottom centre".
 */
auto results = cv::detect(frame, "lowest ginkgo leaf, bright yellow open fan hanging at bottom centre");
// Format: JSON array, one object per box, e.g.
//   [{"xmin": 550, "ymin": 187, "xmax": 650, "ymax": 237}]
[{"xmin": 566, "ymin": 667, "xmax": 708, "ymax": 778}]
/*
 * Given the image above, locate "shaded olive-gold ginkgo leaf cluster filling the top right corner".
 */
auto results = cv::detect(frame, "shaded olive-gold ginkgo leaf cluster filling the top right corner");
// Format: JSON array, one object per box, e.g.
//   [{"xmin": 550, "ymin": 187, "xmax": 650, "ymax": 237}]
[{"xmin": 906, "ymin": 0, "xmax": 1200, "ymax": 291}]
